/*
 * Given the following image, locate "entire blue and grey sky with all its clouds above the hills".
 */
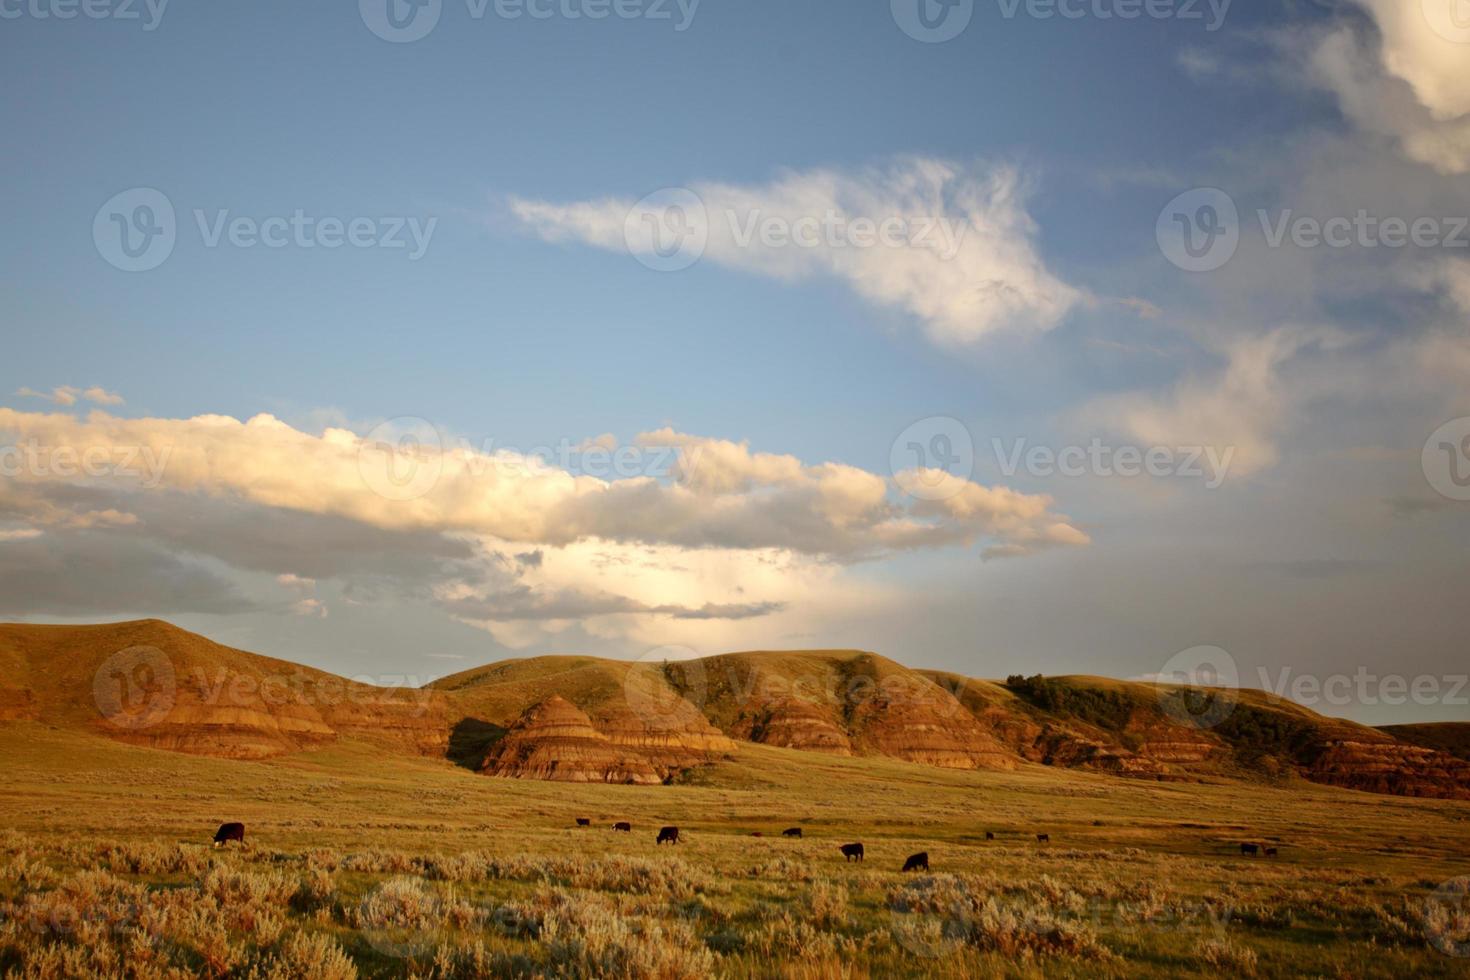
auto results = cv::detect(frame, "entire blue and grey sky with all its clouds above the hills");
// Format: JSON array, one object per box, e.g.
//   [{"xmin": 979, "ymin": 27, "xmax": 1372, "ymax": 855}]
[{"xmin": 0, "ymin": 0, "xmax": 1470, "ymax": 723}]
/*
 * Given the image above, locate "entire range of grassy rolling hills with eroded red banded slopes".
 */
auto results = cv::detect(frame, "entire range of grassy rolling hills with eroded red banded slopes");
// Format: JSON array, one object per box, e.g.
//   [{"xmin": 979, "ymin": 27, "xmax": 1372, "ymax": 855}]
[{"xmin": 0, "ymin": 620, "xmax": 1470, "ymax": 799}]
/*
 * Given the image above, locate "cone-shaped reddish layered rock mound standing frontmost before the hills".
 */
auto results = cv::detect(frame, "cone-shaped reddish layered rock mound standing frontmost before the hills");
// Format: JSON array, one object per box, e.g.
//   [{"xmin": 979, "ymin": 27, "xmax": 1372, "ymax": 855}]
[{"xmin": 481, "ymin": 696, "xmax": 663, "ymax": 785}]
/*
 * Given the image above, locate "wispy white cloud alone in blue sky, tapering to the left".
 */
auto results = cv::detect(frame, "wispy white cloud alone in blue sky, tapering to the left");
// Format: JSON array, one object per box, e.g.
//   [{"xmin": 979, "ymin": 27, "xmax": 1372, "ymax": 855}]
[{"xmin": 510, "ymin": 159, "xmax": 1083, "ymax": 345}]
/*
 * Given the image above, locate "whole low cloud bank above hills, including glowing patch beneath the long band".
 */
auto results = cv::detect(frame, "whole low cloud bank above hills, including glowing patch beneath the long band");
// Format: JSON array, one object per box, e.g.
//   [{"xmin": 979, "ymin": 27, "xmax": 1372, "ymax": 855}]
[{"xmin": 0, "ymin": 407, "xmax": 1088, "ymax": 645}]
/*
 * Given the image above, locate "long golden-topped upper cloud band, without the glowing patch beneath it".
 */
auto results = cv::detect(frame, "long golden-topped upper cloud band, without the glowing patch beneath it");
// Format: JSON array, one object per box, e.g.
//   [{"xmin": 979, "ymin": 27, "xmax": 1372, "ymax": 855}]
[{"xmin": 0, "ymin": 408, "xmax": 1081, "ymax": 558}]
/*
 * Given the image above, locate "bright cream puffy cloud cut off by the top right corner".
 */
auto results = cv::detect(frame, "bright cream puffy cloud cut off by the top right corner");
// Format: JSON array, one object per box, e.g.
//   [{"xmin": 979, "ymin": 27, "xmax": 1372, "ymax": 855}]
[{"xmin": 1308, "ymin": 0, "xmax": 1470, "ymax": 173}]
